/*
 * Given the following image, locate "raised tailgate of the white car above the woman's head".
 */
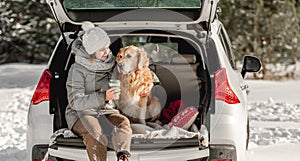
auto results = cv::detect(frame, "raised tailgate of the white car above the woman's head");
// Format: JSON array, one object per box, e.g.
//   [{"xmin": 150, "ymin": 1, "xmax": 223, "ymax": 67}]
[{"xmin": 46, "ymin": 0, "xmax": 219, "ymax": 27}]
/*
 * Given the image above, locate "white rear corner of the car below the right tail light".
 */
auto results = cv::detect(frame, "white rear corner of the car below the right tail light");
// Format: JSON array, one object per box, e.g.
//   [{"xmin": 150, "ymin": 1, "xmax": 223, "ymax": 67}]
[{"xmin": 210, "ymin": 102, "xmax": 248, "ymax": 161}]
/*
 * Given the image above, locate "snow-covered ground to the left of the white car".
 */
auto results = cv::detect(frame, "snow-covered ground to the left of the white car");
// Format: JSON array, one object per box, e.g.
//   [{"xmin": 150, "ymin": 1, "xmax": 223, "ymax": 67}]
[{"xmin": 0, "ymin": 64, "xmax": 45, "ymax": 161}]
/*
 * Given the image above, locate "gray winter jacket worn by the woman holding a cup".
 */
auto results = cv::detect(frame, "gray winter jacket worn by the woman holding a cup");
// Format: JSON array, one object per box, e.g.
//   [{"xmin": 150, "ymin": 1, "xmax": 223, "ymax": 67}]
[{"xmin": 65, "ymin": 38, "xmax": 118, "ymax": 129}]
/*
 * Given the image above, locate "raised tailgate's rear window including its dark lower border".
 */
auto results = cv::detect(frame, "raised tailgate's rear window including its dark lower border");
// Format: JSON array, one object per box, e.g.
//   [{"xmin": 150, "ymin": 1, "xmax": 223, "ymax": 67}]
[{"xmin": 60, "ymin": 0, "xmax": 203, "ymax": 22}]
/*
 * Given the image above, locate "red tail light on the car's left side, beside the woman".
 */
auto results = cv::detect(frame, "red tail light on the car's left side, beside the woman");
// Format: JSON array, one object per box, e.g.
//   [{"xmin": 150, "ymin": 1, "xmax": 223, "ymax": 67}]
[{"xmin": 31, "ymin": 70, "xmax": 52, "ymax": 105}]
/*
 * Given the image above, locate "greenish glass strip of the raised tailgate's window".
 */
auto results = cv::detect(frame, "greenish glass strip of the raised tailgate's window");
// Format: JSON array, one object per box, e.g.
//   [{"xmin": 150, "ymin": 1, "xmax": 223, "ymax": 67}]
[{"xmin": 63, "ymin": 0, "xmax": 201, "ymax": 9}]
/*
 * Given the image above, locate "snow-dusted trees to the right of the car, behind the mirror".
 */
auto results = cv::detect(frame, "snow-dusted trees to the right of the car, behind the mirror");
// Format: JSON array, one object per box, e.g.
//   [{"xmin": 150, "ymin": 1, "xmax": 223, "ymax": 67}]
[{"xmin": 219, "ymin": 0, "xmax": 300, "ymax": 79}]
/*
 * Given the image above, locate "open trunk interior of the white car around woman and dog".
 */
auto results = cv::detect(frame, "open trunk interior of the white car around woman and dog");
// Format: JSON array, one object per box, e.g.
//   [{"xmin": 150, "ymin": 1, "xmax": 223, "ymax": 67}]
[{"xmin": 49, "ymin": 30, "xmax": 211, "ymax": 150}]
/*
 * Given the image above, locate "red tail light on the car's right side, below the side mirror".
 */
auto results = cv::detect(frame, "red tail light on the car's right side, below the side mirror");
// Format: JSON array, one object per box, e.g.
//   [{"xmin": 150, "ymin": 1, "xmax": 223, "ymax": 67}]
[{"xmin": 215, "ymin": 68, "xmax": 240, "ymax": 104}]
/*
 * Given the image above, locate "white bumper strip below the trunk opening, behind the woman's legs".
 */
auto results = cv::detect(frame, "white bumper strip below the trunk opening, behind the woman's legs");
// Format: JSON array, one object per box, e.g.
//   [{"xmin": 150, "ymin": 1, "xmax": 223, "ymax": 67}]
[{"xmin": 48, "ymin": 147, "xmax": 209, "ymax": 161}]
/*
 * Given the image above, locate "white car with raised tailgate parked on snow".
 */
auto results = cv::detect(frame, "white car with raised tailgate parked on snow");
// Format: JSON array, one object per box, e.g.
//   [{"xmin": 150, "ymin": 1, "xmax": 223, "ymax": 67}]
[{"xmin": 27, "ymin": 0, "xmax": 261, "ymax": 161}]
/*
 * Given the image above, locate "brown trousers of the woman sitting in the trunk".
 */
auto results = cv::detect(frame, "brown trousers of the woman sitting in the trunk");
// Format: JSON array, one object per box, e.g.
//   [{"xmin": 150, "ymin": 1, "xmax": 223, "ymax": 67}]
[{"xmin": 72, "ymin": 114, "xmax": 132, "ymax": 161}]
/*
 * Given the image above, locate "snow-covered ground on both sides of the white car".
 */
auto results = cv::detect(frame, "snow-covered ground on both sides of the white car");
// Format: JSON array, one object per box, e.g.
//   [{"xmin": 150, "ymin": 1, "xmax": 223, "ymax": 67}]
[{"xmin": 0, "ymin": 64, "xmax": 300, "ymax": 161}]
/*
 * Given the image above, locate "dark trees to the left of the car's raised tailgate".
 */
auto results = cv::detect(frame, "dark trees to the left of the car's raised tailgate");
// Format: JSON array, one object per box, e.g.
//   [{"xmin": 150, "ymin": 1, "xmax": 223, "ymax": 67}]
[{"xmin": 0, "ymin": 0, "xmax": 59, "ymax": 64}]
